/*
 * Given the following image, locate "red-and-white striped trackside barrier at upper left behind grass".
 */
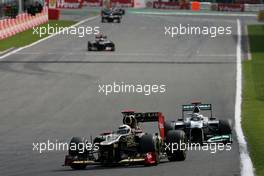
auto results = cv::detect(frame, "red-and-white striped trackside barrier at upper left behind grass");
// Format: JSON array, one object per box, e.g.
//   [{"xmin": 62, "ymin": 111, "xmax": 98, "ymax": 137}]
[{"xmin": 0, "ymin": 8, "xmax": 48, "ymax": 40}]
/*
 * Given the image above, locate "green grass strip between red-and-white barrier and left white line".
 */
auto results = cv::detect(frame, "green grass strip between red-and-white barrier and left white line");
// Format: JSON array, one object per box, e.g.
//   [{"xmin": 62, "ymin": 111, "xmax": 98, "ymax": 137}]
[{"xmin": 0, "ymin": 20, "xmax": 76, "ymax": 51}]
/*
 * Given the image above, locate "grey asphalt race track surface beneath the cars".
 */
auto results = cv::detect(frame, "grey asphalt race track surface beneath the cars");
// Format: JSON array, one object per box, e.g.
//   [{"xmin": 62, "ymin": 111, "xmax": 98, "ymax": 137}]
[{"xmin": 0, "ymin": 14, "xmax": 246, "ymax": 176}]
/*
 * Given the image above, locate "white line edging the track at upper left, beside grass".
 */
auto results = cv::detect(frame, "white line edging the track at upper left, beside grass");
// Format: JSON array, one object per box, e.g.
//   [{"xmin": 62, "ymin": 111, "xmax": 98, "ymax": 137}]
[{"xmin": 0, "ymin": 16, "xmax": 98, "ymax": 60}]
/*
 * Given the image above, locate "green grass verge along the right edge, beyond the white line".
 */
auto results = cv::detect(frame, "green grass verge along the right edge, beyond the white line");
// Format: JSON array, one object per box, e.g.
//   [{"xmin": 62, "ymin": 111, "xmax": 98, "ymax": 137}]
[{"xmin": 242, "ymin": 25, "xmax": 264, "ymax": 176}]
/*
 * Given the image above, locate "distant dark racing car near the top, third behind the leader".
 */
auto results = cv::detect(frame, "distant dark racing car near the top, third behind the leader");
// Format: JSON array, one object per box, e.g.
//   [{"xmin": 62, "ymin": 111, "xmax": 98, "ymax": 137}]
[{"xmin": 101, "ymin": 8, "xmax": 122, "ymax": 23}]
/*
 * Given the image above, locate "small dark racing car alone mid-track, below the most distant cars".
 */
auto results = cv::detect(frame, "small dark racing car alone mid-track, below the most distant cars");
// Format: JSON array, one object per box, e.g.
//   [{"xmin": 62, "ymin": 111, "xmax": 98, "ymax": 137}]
[{"xmin": 87, "ymin": 34, "xmax": 115, "ymax": 51}]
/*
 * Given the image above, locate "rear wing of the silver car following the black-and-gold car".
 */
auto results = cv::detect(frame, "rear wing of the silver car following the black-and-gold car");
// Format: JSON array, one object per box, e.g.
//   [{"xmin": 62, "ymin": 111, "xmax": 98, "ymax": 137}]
[{"xmin": 182, "ymin": 102, "xmax": 213, "ymax": 118}]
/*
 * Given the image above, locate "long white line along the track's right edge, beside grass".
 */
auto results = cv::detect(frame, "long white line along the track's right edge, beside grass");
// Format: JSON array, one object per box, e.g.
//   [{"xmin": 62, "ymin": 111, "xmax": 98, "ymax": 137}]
[{"xmin": 235, "ymin": 19, "xmax": 254, "ymax": 176}]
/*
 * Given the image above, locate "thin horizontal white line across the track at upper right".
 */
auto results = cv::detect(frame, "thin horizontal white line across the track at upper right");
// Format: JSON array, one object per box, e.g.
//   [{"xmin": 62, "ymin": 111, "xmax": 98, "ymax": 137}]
[{"xmin": 131, "ymin": 12, "xmax": 257, "ymax": 17}]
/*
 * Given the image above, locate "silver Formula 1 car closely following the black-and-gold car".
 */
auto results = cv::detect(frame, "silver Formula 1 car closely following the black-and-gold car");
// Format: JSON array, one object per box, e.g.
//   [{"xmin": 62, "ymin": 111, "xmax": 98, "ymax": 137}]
[{"xmin": 165, "ymin": 102, "xmax": 232, "ymax": 144}]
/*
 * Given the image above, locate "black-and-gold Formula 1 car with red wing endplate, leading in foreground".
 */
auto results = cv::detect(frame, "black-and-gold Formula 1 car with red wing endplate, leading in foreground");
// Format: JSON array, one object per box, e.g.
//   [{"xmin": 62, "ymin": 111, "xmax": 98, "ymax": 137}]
[{"xmin": 64, "ymin": 111, "xmax": 186, "ymax": 169}]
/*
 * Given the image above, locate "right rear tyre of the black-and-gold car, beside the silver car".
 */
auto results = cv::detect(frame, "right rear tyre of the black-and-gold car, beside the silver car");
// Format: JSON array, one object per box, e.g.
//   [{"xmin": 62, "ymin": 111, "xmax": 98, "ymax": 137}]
[{"xmin": 165, "ymin": 130, "xmax": 187, "ymax": 161}]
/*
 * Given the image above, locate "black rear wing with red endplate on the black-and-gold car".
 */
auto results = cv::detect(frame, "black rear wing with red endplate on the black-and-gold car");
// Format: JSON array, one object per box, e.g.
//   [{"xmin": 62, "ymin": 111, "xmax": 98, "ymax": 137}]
[{"xmin": 122, "ymin": 111, "xmax": 165, "ymax": 139}]
